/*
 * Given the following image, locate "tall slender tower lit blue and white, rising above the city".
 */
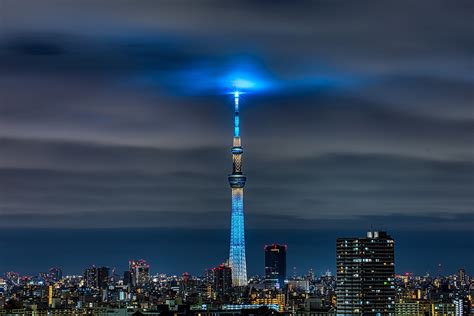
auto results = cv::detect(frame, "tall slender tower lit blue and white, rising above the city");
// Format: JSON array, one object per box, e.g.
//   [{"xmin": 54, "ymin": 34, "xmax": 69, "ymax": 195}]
[{"xmin": 229, "ymin": 92, "xmax": 247, "ymax": 286}]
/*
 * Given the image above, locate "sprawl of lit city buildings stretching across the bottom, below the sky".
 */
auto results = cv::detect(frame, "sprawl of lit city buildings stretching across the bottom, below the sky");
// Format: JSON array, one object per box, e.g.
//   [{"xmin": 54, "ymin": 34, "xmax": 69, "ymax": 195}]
[{"xmin": 0, "ymin": 227, "xmax": 474, "ymax": 316}]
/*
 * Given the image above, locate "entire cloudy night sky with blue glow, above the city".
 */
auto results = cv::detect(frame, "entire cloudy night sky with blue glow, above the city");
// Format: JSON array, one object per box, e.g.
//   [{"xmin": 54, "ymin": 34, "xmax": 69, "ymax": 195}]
[{"xmin": 0, "ymin": 0, "xmax": 474, "ymax": 274}]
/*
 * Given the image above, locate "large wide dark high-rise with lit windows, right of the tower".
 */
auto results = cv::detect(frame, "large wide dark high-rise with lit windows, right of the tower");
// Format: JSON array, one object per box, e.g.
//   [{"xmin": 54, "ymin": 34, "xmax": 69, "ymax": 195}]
[{"xmin": 336, "ymin": 232, "xmax": 395, "ymax": 315}]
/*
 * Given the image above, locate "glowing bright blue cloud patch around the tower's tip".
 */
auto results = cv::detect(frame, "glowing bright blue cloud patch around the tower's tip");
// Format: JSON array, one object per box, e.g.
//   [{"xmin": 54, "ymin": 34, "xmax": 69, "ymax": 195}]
[{"xmin": 128, "ymin": 56, "xmax": 360, "ymax": 95}]
